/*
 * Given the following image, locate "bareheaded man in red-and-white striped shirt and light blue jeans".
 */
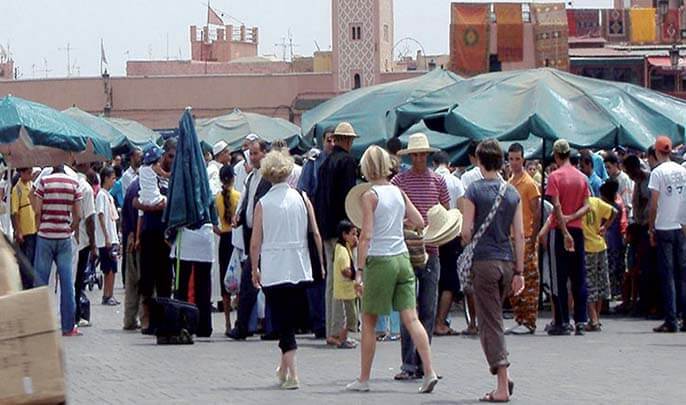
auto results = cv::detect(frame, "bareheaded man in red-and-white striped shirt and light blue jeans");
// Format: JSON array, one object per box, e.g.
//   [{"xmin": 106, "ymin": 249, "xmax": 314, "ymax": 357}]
[{"xmin": 34, "ymin": 165, "xmax": 82, "ymax": 336}]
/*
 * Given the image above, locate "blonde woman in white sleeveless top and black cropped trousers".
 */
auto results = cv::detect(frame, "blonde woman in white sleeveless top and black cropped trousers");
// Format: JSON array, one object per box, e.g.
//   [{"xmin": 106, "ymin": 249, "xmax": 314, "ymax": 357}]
[{"xmin": 250, "ymin": 151, "xmax": 324, "ymax": 389}]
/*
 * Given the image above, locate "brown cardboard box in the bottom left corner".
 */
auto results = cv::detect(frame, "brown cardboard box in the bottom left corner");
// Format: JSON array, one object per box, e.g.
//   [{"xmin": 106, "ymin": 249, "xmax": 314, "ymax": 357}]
[{"xmin": 0, "ymin": 287, "xmax": 65, "ymax": 404}]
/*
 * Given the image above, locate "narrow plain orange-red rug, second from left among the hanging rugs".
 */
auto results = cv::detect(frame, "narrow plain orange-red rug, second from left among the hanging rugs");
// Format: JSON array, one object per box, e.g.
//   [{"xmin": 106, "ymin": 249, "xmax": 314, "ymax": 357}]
[{"xmin": 495, "ymin": 3, "xmax": 524, "ymax": 62}]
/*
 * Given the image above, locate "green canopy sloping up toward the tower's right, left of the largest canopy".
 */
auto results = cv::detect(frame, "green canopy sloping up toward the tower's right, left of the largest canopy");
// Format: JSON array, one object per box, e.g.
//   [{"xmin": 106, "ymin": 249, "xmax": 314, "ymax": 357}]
[{"xmin": 302, "ymin": 69, "xmax": 462, "ymax": 156}]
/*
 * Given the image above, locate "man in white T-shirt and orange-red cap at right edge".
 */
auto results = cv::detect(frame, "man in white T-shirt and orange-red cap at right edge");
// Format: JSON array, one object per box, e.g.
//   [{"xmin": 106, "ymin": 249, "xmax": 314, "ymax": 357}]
[{"xmin": 648, "ymin": 136, "xmax": 686, "ymax": 333}]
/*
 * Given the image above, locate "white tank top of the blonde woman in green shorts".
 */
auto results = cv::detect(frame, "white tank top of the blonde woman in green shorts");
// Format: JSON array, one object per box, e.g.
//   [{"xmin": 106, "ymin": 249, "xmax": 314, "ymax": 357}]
[{"xmin": 367, "ymin": 184, "xmax": 407, "ymax": 256}]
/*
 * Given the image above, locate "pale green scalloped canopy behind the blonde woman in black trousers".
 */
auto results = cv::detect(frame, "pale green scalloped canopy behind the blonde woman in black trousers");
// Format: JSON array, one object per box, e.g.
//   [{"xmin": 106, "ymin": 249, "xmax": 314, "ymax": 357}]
[{"xmin": 195, "ymin": 109, "xmax": 300, "ymax": 151}]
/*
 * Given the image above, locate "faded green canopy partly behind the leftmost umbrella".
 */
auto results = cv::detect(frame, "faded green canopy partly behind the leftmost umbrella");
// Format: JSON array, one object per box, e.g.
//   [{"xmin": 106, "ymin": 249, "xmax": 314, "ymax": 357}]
[{"xmin": 63, "ymin": 107, "xmax": 159, "ymax": 155}]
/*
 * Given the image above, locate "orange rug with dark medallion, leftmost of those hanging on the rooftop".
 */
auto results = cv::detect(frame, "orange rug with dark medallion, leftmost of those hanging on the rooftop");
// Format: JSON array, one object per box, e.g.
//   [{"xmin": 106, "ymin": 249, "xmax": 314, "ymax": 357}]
[{"xmin": 450, "ymin": 3, "xmax": 490, "ymax": 76}]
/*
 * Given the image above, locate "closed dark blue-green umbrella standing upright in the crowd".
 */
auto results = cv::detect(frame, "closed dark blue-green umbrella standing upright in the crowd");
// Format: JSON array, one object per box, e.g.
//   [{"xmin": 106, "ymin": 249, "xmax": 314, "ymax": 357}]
[{"xmin": 164, "ymin": 108, "xmax": 216, "ymax": 234}]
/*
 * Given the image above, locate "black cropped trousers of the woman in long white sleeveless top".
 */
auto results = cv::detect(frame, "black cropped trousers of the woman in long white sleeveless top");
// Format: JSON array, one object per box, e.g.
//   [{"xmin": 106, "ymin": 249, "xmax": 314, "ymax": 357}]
[{"xmin": 262, "ymin": 284, "xmax": 307, "ymax": 353}]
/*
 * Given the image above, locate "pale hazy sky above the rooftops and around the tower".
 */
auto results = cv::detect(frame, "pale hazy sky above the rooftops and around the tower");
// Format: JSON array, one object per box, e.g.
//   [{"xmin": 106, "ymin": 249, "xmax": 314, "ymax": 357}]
[{"xmin": 0, "ymin": 0, "xmax": 612, "ymax": 79}]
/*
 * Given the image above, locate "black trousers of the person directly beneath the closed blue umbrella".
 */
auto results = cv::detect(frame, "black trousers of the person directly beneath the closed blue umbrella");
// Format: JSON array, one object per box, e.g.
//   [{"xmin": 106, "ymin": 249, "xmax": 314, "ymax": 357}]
[{"xmin": 174, "ymin": 260, "xmax": 212, "ymax": 337}]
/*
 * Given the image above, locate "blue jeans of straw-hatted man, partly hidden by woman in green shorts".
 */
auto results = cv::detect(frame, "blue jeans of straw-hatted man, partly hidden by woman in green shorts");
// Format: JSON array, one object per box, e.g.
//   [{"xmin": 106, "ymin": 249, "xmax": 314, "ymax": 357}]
[{"xmin": 400, "ymin": 254, "xmax": 441, "ymax": 373}]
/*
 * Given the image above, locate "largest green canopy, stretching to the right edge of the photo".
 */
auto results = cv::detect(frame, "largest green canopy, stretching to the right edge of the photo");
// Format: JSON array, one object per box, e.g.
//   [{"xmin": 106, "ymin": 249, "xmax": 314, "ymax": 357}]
[{"xmin": 395, "ymin": 68, "xmax": 686, "ymax": 150}]
